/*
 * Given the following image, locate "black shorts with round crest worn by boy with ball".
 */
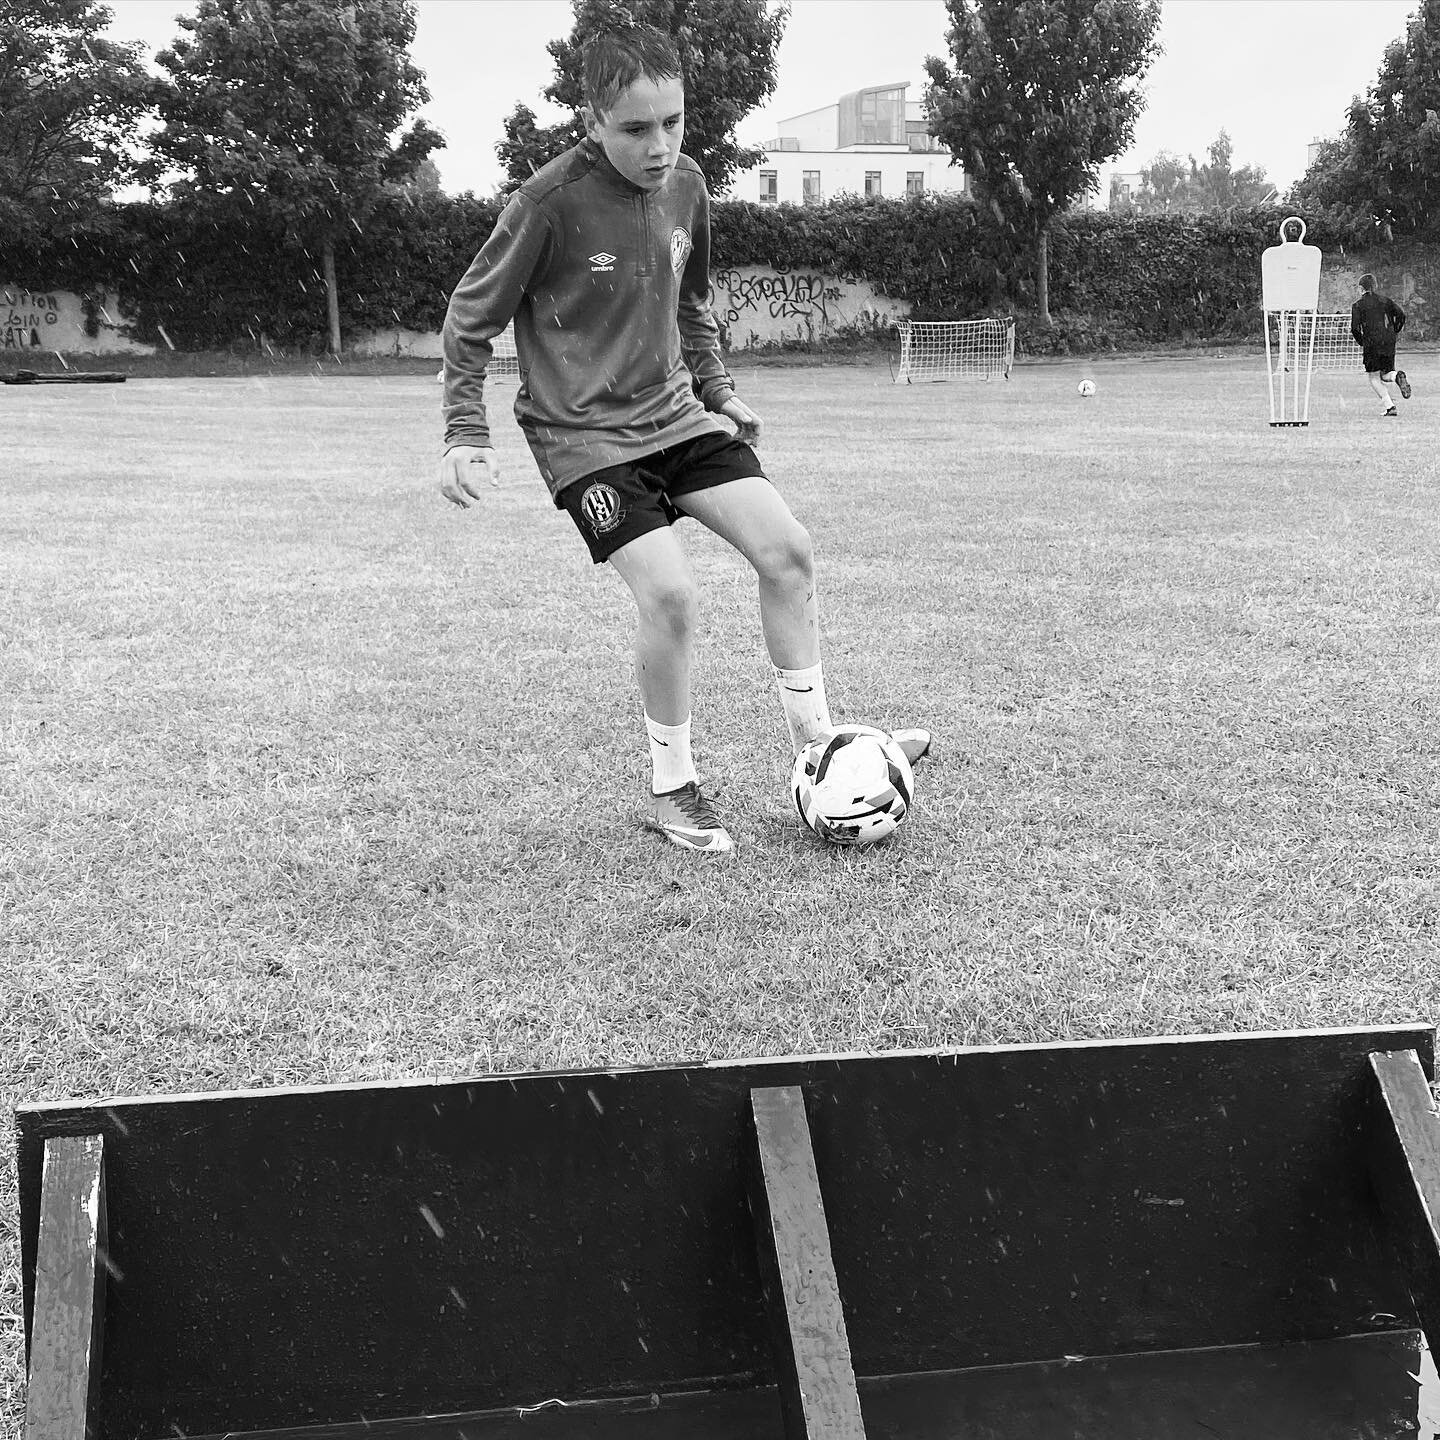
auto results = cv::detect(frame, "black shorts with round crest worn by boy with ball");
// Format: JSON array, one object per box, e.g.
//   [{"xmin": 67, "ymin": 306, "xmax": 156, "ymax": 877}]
[{"xmin": 556, "ymin": 432, "xmax": 765, "ymax": 564}]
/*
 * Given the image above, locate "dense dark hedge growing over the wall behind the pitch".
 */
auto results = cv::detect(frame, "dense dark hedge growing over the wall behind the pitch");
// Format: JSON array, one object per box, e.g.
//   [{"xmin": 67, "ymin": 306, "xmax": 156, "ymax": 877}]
[{"xmin": 0, "ymin": 194, "xmax": 1416, "ymax": 350}]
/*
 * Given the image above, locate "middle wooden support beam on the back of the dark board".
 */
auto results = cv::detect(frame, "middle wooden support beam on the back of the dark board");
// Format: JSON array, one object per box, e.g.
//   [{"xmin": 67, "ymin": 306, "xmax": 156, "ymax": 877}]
[{"xmin": 750, "ymin": 1086, "xmax": 865, "ymax": 1440}]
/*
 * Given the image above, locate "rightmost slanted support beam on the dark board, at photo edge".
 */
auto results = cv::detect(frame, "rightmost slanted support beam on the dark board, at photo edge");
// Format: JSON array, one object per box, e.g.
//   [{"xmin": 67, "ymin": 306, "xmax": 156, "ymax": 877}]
[{"xmin": 1369, "ymin": 1050, "xmax": 1440, "ymax": 1356}]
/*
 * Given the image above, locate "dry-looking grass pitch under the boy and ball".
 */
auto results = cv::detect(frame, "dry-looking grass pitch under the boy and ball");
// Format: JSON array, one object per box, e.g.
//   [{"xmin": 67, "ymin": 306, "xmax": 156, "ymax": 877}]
[{"xmin": 0, "ymin": 354, "xmax": 1440, "ymax": 1434}]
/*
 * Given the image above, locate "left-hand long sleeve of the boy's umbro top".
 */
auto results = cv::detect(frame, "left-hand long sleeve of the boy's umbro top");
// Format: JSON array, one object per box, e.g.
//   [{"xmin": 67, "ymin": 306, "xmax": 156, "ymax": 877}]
[{"xmin": 442, "ymin": 194, "xmax": 552, "ymax": 449}]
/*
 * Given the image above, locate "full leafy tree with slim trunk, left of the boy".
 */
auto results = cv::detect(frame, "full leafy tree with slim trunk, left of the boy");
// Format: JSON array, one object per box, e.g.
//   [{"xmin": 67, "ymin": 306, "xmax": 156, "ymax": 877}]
[{"xmin": 145, "ymin": 0, "xmax": 445, "ymax": 354}]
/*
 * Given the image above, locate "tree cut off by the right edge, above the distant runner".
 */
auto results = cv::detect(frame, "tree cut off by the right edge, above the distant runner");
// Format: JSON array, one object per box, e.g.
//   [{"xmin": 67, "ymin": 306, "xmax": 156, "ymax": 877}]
[{"xmin": 1292, "ymin": 0, "xmax": 1440, "ymax": 235}]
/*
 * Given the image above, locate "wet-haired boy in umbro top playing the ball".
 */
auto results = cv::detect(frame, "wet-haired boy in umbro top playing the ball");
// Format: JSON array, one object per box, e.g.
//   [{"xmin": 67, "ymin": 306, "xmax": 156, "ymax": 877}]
[{"xmin": 441, "ymin": 26, "xmax": 930, "ymax": 854}]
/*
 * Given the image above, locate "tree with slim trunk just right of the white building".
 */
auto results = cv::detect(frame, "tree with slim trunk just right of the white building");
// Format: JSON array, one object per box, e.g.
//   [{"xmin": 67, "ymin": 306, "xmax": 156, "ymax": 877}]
[{"xmin": 924, "ymin": 0, "xmax": 1161, "ymax": 325}]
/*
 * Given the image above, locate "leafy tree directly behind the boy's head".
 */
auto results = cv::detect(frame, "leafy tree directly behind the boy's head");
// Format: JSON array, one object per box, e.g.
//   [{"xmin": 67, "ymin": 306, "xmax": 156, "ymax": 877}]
[{"xmin": 495, "ymin": 0, "xmax": 791, "ymax": 190}]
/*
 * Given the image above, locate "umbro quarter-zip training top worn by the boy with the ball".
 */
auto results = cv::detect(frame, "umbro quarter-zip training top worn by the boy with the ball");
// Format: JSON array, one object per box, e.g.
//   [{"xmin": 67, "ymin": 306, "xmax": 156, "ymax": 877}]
[{"xmin": 444, "ymin": 140, "xmax": 734, "ymax": 504}]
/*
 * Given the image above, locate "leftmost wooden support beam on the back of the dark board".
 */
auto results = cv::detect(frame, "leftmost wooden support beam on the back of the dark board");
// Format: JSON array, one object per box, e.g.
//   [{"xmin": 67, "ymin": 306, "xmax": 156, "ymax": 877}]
[{"xmin": 24, "ymin": 1135, "xmax": 109, "ymax": 1440}]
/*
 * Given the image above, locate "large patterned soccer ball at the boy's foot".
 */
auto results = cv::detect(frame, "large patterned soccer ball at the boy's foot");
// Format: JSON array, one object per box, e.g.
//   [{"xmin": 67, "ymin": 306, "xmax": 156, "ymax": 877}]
[{"xmin": 791, "ymin": 724, "xmax": 914, "ymax": 845}]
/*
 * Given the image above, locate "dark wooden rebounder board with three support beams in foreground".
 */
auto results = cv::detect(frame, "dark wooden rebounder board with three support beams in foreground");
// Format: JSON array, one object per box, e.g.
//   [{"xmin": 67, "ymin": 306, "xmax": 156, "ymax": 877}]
[{"xmin": 17, "ymin": 1025, "xmax": 1440, "ymax": 1440}]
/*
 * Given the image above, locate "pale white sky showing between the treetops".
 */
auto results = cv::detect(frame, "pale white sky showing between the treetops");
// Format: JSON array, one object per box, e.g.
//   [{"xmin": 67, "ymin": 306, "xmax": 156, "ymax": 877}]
[{"xmin": 107, "ymin": 0, "xmax": 1418, "ymax": 194}]
